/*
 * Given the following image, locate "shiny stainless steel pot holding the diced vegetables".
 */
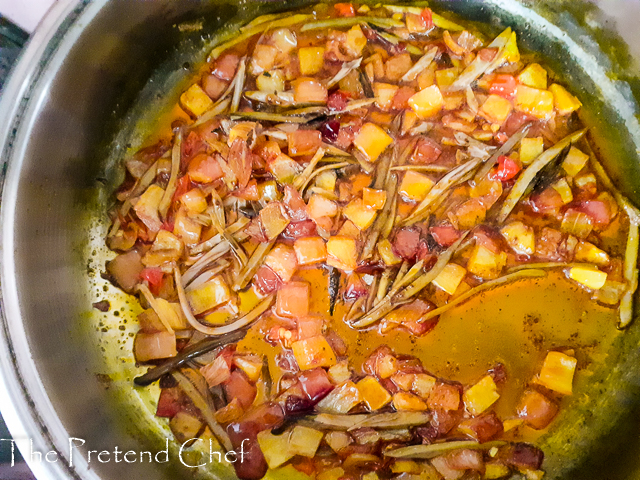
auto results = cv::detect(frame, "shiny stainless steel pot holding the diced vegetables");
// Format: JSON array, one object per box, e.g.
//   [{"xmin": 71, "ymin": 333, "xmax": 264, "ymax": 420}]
[{"xmin": 0, "ymin": 0, "xmax": 640, "ymax": 480}]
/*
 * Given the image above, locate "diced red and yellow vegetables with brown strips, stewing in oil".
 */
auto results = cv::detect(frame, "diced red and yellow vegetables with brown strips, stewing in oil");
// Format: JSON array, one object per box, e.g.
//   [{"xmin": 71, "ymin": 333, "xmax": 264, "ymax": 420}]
[{"xmin": 107, "ymin": 3, "xmax": 640, "ymax": 480}]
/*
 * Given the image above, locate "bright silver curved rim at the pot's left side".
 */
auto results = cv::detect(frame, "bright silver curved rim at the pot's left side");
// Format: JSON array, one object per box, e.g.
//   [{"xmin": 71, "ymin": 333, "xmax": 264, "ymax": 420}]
[{"xmin": 0, "ymin": 0, "xmax": 105, "ymax": 480}]
